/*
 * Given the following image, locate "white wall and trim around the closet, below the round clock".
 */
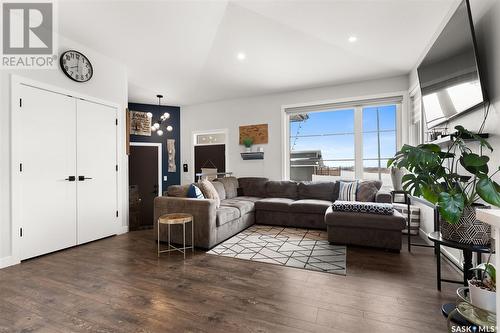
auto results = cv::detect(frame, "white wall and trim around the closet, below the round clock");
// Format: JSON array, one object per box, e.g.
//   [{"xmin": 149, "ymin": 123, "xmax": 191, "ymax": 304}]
[{"xmin": 0, "ymin": 37, "xmax": 128, "ymax": 268}]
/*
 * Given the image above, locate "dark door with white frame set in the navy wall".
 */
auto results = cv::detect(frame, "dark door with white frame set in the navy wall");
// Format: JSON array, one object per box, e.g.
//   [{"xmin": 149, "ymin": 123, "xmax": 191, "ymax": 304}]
[{"xmin": 128, "ymin": 142, "xmax": 162, "ymax": 231}]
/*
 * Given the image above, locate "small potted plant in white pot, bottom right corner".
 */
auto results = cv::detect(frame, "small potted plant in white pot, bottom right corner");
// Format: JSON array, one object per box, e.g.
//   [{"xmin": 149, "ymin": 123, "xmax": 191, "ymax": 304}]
[{"xmin": 469, "ymin": 255, "xmax": 497, "ymax": 313}]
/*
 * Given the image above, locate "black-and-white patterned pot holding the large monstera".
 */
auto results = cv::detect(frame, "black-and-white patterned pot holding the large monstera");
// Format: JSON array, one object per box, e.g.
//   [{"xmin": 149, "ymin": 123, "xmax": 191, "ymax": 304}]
[{"xmin": 440, "ymin": 206, "xmax": 491, "ymax": 245}]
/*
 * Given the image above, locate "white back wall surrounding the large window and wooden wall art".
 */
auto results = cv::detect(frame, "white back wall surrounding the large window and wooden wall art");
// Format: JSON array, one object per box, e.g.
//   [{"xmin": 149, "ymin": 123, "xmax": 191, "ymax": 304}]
[{"xmin": 181, "ymin": 76, "xmax": 408, "ymax": 184}]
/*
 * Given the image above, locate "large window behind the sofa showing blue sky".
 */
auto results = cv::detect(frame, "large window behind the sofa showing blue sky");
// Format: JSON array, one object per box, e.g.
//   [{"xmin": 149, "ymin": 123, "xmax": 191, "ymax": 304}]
[{"xmin": 286, "ymin": 100, "xmax": 401, "ymax": 187}]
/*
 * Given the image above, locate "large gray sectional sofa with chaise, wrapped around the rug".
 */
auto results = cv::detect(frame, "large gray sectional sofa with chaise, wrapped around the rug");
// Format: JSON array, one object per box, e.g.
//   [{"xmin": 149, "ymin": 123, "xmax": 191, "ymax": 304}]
[{"xmin": 154, "ymin": 177, "xmax": 404, "ymax": 250}]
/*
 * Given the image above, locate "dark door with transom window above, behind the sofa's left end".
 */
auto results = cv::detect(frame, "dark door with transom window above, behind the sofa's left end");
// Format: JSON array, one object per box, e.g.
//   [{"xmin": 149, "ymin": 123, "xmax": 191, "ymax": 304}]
[{"xmin": 194, "ymin": 131, "xmax": 226, "ymax": 182}]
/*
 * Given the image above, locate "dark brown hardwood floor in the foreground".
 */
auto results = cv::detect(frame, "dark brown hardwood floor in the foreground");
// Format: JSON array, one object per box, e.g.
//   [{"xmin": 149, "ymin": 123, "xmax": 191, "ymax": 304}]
[{"xmin": 0, "ymin": 230, "xmax": 459, "ymax": 333}]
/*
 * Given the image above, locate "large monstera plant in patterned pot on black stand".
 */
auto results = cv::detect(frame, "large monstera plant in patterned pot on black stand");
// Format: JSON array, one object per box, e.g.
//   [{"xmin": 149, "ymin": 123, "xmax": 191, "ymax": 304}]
[{"xmin": 387, "ymin": 126, "xmax": 500, "ymax": 245}]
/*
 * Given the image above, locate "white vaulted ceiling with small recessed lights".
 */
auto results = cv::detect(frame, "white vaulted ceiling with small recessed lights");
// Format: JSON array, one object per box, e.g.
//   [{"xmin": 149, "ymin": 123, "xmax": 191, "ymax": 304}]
[{"xmin": 59, "ymin": 0, "xmax": 457, "ymax": 105}]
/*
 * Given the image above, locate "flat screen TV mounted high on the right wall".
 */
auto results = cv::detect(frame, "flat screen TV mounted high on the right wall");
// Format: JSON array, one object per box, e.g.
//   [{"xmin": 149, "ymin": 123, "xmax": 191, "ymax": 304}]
[{"xmin": 417, "ymin": 0, "xmax": 486, "ymax": 128}]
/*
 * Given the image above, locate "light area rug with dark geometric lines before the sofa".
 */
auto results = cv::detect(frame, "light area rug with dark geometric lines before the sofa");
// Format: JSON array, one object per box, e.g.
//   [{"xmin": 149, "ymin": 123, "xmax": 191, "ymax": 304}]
[{"xmin": 207, "ymin": 225, "xmax": 346, "ymax": 275}]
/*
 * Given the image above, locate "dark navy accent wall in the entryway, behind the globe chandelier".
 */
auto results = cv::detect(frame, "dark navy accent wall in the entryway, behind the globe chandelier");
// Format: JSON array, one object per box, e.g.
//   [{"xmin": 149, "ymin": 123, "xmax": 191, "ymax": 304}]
[{"xmin": 128, "ymin": 103, "xmax": 181, "ymax": 191}]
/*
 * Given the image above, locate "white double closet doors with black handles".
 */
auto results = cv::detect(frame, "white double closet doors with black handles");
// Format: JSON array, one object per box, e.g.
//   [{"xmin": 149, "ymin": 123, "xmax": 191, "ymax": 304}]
[{"xmin": 16, "ymin": 85, "xmax": 118, "ymax": 260}]
